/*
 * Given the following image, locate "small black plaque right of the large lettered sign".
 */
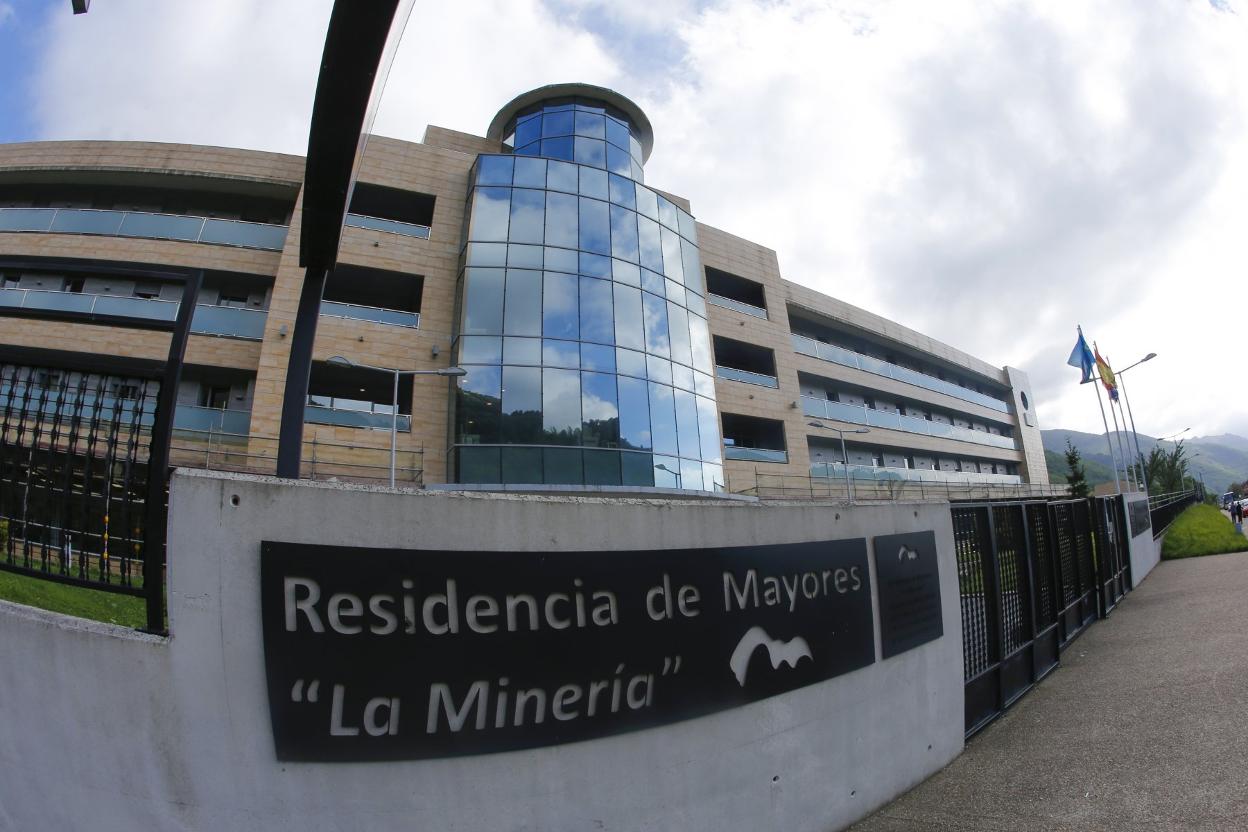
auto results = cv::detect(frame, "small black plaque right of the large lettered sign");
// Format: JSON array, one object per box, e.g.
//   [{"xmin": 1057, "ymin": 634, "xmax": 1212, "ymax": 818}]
[{"xmin": 874, "ymin": 531, "xmax": 945, "ymax": 659}]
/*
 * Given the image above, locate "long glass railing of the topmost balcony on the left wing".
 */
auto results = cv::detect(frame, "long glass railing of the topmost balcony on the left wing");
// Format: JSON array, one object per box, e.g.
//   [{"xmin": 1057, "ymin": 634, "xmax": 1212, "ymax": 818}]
[{"xmin": 0, "ymin": 208, "xmax": 287, "ymax": 251}]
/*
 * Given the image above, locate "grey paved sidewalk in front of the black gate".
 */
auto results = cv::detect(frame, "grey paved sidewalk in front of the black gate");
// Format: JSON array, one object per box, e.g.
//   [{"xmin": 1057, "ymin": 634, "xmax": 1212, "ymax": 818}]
[{"xmin": 852, "ymin": 553, "xmax": 1248, "ymax": 832}]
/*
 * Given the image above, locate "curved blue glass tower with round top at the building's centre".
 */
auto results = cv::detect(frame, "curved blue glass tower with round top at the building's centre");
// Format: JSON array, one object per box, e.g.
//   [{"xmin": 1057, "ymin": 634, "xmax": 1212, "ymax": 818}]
[{"xmin": 452, "ymin": 84, "xmax": 724, "ymax": 490}]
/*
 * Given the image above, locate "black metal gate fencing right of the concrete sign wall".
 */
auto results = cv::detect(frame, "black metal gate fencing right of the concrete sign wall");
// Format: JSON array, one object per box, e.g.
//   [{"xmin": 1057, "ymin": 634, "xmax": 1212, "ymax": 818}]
[{"xmin": 951, "ymin": 496, "xmax": 1131, "ymax": 736}]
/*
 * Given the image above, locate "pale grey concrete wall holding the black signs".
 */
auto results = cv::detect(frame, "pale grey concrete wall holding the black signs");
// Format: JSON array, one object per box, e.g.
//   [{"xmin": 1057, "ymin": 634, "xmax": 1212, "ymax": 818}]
[{"xmin": 0, "ymin": 472, "xmax": 962, "ymax": 832}]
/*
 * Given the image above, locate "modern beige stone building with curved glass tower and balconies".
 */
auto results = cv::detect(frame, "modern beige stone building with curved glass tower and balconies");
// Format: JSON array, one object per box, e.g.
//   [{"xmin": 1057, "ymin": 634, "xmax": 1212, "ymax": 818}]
[{"xmin": 0, "ymin": 84, "xmax": 1048, "ymax": 493}]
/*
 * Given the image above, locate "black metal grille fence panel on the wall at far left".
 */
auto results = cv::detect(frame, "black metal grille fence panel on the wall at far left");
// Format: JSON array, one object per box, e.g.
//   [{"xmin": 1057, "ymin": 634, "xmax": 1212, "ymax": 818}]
[{"xmin": 0, "ymin": 364, "xmax": 163, "ymax": 595}]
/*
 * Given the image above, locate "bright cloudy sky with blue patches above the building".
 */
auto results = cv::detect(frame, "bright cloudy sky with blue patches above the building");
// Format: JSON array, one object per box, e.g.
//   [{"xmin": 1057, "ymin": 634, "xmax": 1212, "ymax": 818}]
[{"xmin": 0, "ymin": 0, "xmax": 1248, "ymax": 437}]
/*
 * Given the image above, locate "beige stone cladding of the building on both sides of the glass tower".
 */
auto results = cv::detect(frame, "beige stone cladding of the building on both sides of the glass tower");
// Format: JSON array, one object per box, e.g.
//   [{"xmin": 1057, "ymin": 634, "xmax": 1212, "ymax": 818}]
[{"xmin": 0, "ymin": 127, "xmax": 1047, "ymax": 490}]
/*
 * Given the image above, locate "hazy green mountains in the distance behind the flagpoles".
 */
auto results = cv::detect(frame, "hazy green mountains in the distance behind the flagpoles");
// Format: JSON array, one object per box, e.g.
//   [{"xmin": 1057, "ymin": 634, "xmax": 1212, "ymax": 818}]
[{"xmin": 1040, "ymin": 428, "xmax": 1248, "ymax": 493}]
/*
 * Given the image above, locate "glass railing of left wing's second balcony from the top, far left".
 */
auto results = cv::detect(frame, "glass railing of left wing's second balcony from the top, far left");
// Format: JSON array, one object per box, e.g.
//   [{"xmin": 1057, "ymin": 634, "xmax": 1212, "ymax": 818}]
[{"xmin": 0, "ymin": 289, "xmax": 267, "ymax": 341}]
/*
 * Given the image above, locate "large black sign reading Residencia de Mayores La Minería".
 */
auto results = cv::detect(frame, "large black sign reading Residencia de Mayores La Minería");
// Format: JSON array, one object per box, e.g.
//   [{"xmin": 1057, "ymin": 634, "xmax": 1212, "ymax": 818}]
[{"xmin": 261, "ymin": 539, "xmax": 875, "ymax": 761}]
